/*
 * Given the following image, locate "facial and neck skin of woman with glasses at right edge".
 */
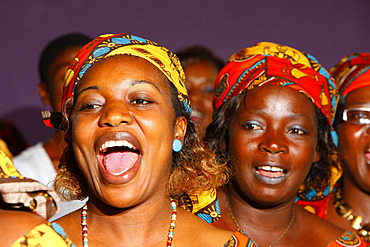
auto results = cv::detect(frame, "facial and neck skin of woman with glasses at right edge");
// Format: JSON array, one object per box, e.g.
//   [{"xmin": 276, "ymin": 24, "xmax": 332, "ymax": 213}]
[{"xmin": 327, "ymin": 86, "xmax": 370, "ymax": 229}]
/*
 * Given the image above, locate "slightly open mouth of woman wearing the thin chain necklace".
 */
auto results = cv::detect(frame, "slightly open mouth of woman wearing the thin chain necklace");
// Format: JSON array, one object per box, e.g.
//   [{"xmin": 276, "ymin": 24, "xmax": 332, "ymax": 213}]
[{"xmin": 254, "ymin": 162, "xmax": 288, "ymax": 185}]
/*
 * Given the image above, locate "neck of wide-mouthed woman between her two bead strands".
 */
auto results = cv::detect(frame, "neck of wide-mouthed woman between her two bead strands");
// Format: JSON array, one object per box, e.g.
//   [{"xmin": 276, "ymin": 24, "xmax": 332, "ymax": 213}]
[{"xmin": 87, "ymin": 196, "xmax": 172, "ymax": 246}]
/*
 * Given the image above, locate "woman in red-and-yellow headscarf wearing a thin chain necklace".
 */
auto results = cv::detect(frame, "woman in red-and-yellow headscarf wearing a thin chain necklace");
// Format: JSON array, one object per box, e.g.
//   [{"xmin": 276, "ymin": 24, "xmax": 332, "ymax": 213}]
[{"xmin": 206, "ymin": 42, "xmax": 366, "ymax": 247}]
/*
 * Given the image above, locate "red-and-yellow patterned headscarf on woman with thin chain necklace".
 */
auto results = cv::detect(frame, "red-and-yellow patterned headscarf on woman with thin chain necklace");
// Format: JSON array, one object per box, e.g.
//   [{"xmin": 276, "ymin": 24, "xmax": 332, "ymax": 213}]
[{"xmin": 213, "ymin": 42, "xmax": 338, "ymax": 124}]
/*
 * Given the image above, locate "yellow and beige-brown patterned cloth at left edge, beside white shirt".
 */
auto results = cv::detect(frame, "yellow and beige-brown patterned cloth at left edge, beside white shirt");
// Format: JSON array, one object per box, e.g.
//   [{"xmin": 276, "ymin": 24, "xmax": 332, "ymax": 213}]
[{"xmin": 0, "ymin": 149, "xmax": 60, "ymax": 219}]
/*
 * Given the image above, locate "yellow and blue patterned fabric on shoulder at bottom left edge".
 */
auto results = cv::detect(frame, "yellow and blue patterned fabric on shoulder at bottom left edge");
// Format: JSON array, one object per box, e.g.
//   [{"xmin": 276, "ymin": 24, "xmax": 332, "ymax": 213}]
[{"xmin": 11, "ymin": 223, "xmax": 75, "ymax": 247}]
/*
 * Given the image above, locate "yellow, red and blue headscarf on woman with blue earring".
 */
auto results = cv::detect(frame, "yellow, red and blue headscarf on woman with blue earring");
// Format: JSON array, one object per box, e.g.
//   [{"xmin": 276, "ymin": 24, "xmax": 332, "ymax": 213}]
[{"xmin": 43, "ymin": 33, "xmax": 191, "ymax": 127}]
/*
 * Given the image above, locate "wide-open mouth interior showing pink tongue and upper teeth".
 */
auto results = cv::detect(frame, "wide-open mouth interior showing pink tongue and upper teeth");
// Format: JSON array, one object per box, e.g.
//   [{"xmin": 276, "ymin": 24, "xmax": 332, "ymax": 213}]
[{"xmin": 98, "ymin": 140, "xmax": 140, "ymax": 176}]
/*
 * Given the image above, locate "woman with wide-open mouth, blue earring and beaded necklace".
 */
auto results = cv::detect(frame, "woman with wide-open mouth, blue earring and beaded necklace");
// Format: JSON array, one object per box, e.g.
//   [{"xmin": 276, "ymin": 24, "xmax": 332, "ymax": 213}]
[{"xmin": 45, "ymin": 33, "xmax": 251, "ymax": 247}]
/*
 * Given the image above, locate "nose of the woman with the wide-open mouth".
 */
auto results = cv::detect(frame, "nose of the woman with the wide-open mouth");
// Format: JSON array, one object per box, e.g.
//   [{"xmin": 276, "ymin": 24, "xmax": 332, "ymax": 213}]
[{"xmin": 99, "ymin": 102, "xmax": 132, "ymax": 127}]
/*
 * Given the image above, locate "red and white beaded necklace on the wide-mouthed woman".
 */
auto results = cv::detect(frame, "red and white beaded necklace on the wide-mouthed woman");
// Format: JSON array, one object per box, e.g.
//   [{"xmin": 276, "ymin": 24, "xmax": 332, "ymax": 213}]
[{"xmin": 81, "ymin": 198, "xmax": 177, "ymax": 247}]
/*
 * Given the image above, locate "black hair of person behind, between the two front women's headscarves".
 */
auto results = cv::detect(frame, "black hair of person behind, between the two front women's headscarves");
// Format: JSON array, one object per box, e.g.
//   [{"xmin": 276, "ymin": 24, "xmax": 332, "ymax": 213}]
[{"xmin": 176, "ymin": 45, "xmax": 225, "ymax": 71}]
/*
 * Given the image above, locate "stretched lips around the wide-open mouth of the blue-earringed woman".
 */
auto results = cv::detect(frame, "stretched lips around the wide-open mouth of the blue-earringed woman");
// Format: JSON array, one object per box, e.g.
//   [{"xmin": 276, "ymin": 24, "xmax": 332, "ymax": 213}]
[{"xmin": 95, "ymin": 132, "xmax": 143, "ymax": 184}]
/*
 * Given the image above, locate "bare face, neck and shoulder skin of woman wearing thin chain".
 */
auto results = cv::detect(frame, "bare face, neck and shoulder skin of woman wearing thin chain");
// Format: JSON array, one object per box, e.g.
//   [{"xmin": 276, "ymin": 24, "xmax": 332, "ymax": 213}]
[{"xmin": 216, "ymin": 85, "xmax": 344, "ymax": 247}]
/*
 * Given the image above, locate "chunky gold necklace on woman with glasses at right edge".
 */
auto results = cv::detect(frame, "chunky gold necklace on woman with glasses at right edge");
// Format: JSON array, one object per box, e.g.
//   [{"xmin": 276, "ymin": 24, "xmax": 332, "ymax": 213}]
[{"xmin": 334, "ymin": 189, "xmax": 370, "ymax": 243}]
